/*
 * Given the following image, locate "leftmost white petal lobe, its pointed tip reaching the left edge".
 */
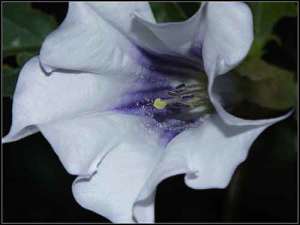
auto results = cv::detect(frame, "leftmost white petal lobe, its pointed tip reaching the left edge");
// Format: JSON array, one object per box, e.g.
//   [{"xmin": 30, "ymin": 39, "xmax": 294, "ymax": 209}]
[{"xmin": 3, "ymin": 57, "xmax": 129, "ymax": 142}]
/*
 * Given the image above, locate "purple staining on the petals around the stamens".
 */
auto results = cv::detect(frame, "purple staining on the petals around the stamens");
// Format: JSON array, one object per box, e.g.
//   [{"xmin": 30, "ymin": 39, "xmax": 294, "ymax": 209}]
[{"xmin": 114, "ymin": 48, "xmax": 206, "ymax": 145}]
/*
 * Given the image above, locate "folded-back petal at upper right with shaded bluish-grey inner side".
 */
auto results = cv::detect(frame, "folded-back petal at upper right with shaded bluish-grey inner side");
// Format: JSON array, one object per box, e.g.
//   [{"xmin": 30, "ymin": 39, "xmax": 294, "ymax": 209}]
[{"xmin": 131, "ymin": 2, "xmax": 253, "ymax": 67}]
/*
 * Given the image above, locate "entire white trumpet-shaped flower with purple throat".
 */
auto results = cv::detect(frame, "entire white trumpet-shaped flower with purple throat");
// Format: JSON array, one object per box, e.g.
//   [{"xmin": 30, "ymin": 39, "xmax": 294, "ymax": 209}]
[{"xmin": 3, "ymin": 2, "xmax": 288, "ymax": 222}]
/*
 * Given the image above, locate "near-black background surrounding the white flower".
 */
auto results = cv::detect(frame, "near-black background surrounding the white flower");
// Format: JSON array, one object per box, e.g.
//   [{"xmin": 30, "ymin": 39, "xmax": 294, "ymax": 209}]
[{"xmin": 2, "ymin": 3, "xmax": 298, "ymax": 222}]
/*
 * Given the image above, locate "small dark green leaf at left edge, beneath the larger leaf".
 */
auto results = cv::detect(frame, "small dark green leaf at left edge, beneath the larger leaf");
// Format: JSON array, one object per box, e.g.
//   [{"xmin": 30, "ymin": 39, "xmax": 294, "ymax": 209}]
[{"xmin": 1, "ymin": 65, "xmax": 20, "ymax": 97}]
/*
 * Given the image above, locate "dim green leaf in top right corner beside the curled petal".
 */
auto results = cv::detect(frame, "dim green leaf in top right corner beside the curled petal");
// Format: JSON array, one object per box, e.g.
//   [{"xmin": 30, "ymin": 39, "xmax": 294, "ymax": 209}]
[{"xmin": 248, "ymin": 2, "xmax": 298, "ymax": 57}]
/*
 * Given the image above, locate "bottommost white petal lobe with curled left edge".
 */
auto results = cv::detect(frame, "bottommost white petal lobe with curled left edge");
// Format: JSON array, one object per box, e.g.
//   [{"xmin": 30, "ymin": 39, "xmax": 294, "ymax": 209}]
[{"xmin": 73, "ymin": 125, "xmax": 162, "ymax": 223}]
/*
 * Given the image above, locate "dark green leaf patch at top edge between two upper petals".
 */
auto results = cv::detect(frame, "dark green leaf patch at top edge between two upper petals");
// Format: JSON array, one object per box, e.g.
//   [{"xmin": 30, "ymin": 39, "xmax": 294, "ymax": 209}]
[{"xmin": 150, "ymin": 2, "xmax": 187, "ymax": 22}]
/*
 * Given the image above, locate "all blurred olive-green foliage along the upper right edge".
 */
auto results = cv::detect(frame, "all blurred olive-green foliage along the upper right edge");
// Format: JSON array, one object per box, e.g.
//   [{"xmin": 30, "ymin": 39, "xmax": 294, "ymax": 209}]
[{"xmin": 237, "ymin": 2, "xmax": 298, "ymax": 110}]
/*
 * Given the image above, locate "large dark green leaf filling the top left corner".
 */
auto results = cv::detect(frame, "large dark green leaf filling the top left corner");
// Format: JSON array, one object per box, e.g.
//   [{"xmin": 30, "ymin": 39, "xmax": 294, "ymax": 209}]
[{"xmin": 3, "ymin": 2, "xmax": 56, "ymax": 57}]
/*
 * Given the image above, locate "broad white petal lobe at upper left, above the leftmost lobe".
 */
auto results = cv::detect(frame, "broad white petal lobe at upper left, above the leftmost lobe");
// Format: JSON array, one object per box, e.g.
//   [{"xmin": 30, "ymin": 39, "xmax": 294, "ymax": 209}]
[{"xmin": 40, "ymin": 2, "xmax": 141, "ymax": 77}]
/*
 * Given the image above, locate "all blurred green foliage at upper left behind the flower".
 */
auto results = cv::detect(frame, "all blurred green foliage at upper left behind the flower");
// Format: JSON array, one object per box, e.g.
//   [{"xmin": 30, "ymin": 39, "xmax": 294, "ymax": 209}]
[{"xmin": 2, "ymin": 2, "xmax": 57, "ymax": 96}]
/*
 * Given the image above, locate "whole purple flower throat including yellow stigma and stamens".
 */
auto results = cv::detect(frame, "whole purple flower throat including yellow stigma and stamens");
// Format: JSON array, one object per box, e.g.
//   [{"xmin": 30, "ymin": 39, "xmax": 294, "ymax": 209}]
[{"xmin": 114, "ymin": 50, "xmax": 213, "ymax": 144}]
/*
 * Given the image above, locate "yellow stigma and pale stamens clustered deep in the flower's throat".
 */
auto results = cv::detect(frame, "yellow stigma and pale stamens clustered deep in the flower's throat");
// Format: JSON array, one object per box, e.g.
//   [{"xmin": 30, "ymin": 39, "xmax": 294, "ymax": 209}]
[{"xmin": 145, "ymin": 69, "xmax": 214, "ymax": 123}]
